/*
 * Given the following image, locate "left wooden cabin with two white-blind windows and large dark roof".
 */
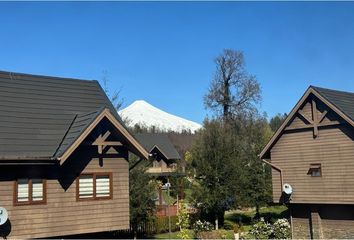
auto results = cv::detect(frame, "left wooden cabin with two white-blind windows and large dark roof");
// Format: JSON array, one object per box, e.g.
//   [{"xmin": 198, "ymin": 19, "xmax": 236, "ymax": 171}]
[{"xmin": 0, "ymin": 72, "xmax": 149, "ymax": 238}]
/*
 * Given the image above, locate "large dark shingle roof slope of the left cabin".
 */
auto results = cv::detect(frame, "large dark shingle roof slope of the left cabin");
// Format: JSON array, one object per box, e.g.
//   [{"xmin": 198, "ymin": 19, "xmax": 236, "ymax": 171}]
[{"xmin": 0, "ymin": 71, "xmax": 121, "ymax": 159}]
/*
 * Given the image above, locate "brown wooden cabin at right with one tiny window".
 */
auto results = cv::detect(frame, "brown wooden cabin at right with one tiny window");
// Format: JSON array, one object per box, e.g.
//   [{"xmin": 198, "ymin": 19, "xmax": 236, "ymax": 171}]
[{"xmin": 260, "ymin": 86, "xmax": 354, "ymax": 239}]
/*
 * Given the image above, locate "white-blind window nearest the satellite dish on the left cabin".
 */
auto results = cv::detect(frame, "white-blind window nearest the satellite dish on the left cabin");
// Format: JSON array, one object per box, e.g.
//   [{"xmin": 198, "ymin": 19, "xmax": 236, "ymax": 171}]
[{"xmin": 14, "ymin": 178, "xmax": 45, "ymax": 205}]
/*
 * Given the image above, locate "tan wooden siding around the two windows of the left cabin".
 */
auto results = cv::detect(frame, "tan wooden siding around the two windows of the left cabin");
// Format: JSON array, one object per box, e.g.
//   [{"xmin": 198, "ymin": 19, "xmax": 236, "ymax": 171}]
[{"xmin": 0, "ymin": 149, "xmax": 129, "ymax": 238}]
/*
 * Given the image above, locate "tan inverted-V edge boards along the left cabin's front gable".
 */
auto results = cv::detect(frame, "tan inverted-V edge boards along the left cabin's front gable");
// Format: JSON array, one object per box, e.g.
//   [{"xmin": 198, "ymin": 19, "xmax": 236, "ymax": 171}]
[{"xmin": 58, "ymin": 108, "xmax": 149, "ymax": 164}]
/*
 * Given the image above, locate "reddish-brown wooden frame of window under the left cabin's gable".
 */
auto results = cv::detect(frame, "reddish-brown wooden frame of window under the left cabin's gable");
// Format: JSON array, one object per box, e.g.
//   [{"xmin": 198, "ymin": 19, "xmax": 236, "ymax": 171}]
[{"xmin": 76, "ymin": 172, "xmax": 113, "ymax": 202}]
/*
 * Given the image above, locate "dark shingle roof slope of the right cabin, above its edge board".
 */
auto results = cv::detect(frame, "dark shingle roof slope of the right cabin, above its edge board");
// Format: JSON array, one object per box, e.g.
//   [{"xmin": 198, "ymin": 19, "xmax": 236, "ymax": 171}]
[{"xmin": 311, "ymin": 86, "xmax": 354, "ymax": 121}]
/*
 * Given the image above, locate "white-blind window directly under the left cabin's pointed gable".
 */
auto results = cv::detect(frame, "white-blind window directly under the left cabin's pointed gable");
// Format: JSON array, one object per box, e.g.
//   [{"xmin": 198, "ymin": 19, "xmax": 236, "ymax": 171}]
[{"xmin": 77, "ymin": 173, "xmax": 112, "ymax": 200}]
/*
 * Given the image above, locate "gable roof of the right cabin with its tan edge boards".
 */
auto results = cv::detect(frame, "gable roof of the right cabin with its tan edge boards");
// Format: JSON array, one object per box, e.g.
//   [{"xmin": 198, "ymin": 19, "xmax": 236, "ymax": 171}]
[{"xmin": 259, "ymin": 86, "xmax": 354, "ymax": 159}]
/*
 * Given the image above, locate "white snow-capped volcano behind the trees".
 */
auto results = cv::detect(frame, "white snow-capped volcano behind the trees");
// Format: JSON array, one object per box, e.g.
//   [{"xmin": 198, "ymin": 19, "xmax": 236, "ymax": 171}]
[{"xmin": 118, "ymin": 100, "xmax": 202, "ymax": 133}]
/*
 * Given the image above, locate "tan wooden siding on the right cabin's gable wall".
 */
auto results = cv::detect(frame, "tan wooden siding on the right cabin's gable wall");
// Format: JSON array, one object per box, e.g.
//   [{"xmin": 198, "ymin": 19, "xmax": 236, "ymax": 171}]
[{"xmin": 271, "ymin": 96, "xmax": 354, "ymax": 203}]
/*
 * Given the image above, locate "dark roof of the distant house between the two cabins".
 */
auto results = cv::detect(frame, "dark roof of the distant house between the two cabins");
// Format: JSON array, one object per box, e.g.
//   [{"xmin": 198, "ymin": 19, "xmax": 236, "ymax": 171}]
[{"xmin": 135, "ymin": 133, "xmax": 181, "ymax": 160}]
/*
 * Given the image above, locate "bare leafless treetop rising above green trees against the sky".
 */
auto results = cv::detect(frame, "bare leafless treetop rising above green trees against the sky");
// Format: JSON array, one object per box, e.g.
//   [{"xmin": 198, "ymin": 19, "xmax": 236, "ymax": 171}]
[{"xmin": 204, "ymin": 49, "xmax": 261, "ymax": 120}]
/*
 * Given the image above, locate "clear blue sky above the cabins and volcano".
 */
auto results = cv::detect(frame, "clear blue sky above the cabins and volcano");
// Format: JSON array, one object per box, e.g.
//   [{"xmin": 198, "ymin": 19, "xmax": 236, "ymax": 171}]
[{"xmin": 0, "ymin": 2, "xmax": 354, "ymax": 122}]
